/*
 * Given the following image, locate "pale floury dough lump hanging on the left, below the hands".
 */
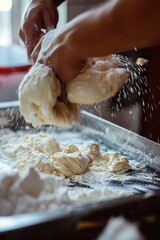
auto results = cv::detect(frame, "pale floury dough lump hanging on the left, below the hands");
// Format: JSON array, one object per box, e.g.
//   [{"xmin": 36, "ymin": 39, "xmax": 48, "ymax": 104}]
[{"xmin": 18, "ymin": 63, "xmax": 79, "ymax": 127}]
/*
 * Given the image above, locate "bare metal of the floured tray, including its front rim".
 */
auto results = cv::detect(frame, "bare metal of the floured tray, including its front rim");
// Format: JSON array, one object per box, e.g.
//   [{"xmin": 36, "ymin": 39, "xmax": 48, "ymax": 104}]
[{"xmin": 0, "ymin": 101, "xmax": 160, "ymax": 239}]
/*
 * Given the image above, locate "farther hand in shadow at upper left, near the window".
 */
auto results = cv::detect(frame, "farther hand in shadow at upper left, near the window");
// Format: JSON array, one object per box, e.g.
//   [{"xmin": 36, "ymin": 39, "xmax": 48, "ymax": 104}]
[{"xmin": 19, "ymin": 0, "xmax": 59, "ymax": 60}]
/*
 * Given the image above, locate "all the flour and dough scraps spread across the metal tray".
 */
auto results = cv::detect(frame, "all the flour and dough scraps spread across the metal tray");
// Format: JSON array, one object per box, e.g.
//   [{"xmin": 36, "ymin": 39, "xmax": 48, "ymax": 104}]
[{"xmin": 0, "ymin": 129, "xmax": 142, "ymax": 215}]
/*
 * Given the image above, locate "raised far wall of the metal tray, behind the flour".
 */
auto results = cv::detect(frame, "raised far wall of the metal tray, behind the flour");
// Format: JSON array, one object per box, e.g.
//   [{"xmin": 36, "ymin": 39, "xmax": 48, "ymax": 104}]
[{"xmin": 0, "ymin": 101, "xmax": 160, "ymax": 172}]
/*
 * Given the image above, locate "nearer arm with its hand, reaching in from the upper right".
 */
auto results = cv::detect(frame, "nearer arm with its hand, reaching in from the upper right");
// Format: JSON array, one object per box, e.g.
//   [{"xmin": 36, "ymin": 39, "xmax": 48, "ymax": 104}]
[{"xmin": 33, "ymin": 0, "xmax": 160, "ymax": 82}]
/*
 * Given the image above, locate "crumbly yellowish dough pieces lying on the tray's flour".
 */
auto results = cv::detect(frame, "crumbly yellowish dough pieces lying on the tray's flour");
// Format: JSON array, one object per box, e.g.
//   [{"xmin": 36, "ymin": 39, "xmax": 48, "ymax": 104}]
[{"xmin": 1, "ymin": 132, "xmax": 131, "ymax": 177}]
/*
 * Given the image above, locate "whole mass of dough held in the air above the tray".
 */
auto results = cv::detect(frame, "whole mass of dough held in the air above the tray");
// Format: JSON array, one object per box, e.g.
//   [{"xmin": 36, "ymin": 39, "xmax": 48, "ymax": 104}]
[{"xmin": 18, "ymin": 56, "xmax": 127, "ymax": 127}]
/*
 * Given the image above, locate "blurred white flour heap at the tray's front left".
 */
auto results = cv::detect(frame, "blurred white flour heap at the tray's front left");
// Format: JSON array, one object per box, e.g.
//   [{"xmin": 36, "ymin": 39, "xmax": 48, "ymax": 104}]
[{"xmin": 0, "ymin": 168, "xmax": 72, "ymax": 216}]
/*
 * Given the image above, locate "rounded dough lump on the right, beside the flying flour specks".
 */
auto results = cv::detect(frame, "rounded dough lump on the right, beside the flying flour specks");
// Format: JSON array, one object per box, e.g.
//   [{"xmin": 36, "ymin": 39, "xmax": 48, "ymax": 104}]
[{"xmin": 66, "ymin": 58, "xmax": 128, "ymax": 104}]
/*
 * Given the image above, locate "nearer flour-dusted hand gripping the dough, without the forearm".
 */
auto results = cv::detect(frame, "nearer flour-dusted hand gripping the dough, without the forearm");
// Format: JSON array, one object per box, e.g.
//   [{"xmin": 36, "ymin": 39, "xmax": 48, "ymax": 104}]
[{"xmin": 31, "ymin": 28, "xmax": 86, "ymax": 83}]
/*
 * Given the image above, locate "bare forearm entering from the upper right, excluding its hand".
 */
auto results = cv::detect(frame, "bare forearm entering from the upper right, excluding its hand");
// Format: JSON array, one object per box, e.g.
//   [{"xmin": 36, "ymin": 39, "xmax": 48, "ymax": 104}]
[{"xmin": 65, "ymin": 0, "xmax": 160, "ymax": 58}]
